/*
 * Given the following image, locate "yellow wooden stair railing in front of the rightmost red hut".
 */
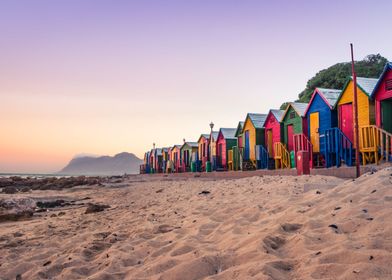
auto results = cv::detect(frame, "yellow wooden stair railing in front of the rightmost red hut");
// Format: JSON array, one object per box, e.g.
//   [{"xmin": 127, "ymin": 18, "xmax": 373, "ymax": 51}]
[{"xmin": 359, "ymin": 125, "xmax": 392, "ymax": 165}]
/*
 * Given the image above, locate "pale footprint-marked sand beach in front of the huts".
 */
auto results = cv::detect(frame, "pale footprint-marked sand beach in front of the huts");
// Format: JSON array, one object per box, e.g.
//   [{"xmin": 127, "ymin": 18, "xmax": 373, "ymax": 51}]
[{"xmin": 0, "ymin": 168, "xmax": 392, "ymax": 280}]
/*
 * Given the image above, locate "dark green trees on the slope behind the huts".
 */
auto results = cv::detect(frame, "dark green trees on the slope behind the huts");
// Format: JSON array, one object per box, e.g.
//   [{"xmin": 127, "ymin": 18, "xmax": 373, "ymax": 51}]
[{"xmin": 280, "ymin": 54, "xmax": 388, "ymax": 109}]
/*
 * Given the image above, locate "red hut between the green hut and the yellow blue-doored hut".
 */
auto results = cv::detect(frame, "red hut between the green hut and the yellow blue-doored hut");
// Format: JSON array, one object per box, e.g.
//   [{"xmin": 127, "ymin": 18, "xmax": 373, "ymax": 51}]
[{"xmin": 264, "ymin": 109, "xmax": 284, "ymax": 158}]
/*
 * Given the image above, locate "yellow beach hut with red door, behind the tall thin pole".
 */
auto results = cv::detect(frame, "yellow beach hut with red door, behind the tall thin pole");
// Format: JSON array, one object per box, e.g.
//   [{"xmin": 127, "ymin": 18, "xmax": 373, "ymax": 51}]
[{"xmin": 337, "ymin": 77, "xmax": 378, "ymax": 164}]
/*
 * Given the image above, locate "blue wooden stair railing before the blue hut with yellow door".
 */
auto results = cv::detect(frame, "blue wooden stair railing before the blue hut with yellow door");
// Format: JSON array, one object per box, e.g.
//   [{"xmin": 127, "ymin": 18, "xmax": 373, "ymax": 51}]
[{"xmin": 320, "ymin": 127, "xmax": 354, "ymax": 167}]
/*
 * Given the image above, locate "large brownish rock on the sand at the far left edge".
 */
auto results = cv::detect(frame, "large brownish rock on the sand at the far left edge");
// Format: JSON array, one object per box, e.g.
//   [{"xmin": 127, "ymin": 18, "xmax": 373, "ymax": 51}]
[{"xmin": 0, "ymin": 198, "xmax": 35, "ymax": 222}]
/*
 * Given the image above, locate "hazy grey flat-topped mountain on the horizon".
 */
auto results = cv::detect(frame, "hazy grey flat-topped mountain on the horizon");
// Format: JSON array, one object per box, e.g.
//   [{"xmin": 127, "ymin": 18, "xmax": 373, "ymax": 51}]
[{"xmin": 58, "ymin": 153, "xmax": 143, "ymax": 175}]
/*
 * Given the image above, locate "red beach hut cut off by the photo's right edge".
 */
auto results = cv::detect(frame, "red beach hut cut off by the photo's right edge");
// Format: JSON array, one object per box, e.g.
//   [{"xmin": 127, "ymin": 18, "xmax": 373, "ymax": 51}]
[{"xmin": 371, "ymin": 62, "xmax": 392, "ymax": 163}]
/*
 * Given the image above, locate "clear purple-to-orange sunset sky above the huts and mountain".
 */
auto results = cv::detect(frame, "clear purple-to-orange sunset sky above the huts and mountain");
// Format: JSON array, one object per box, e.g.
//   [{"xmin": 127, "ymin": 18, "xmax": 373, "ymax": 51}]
[{"xmin": 0, "ymin": 0, "xmax": 392, "ymax": 173}]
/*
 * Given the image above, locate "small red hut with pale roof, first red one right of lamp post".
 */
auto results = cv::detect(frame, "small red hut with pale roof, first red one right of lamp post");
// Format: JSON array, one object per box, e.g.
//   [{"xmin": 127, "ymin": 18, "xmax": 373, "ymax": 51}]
[{"xmin": 216, "ymin": 128, "xmax": 237, "ymax": 170}]
